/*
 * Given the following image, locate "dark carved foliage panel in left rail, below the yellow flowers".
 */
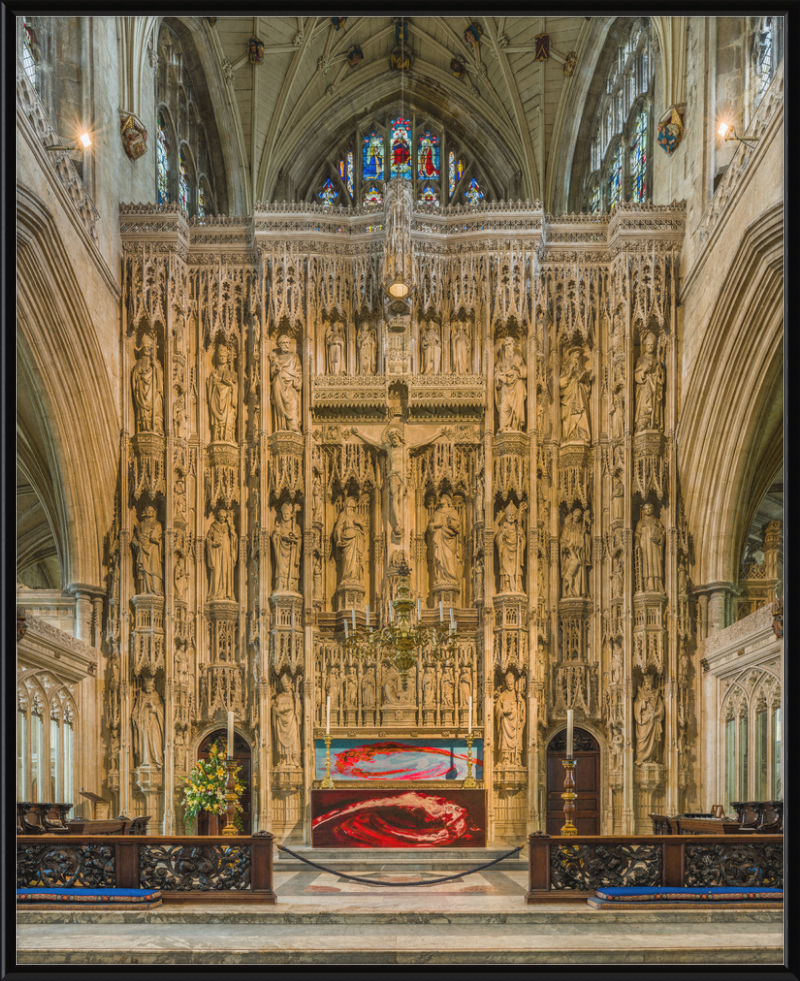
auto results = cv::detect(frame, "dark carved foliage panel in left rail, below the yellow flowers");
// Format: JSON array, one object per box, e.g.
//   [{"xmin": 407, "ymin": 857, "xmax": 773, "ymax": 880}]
[{"xmin": 139, "ymin": 845, "xmax": 250, "ymax": 892}]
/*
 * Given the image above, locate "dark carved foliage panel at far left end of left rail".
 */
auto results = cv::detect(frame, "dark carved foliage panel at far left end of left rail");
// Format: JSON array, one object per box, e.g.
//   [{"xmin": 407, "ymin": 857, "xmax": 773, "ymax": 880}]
[{"xmin": 17, "ymin": 844, "xmax": 116, "ymax": 889}]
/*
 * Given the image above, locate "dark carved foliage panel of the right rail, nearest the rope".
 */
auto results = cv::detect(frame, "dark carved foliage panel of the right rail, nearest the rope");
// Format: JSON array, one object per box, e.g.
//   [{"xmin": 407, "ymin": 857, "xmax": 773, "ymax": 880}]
[{"xmin": 550, "ymin": 844, "xmax": 662, "ymax": 892}]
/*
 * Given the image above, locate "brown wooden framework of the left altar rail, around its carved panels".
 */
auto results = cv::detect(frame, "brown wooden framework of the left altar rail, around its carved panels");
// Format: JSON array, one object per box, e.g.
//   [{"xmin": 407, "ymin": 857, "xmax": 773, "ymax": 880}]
[{"xmin": 17, "ymin": 834, "xmax": 275, "ymax": 903}]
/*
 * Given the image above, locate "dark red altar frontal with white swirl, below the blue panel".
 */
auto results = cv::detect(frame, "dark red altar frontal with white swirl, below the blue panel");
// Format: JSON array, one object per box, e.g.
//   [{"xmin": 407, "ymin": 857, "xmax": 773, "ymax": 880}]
[{"xmin": 311, "ymin": 788, "xmax": 486, "ymax": 848}]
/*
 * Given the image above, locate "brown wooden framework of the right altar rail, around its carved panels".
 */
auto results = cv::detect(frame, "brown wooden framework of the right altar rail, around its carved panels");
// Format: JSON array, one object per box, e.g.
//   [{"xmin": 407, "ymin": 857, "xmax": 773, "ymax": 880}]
[{"xmin": 525, "ymin": 833, "xmax": 783, "ymax": 903}]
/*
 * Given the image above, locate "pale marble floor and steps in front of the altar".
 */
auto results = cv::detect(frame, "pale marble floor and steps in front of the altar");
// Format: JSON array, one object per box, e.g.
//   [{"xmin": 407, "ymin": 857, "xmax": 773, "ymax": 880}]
[{"xmin": 17, "ymin": 870, "xmax": 783, "ymax": 965}]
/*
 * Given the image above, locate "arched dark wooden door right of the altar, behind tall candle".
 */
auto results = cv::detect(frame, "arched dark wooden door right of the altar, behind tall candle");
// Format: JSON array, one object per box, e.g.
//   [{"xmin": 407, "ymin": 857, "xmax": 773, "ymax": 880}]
[{"xmin": 547, "ymin": 728, "xmax": 600, "ymax": 835}]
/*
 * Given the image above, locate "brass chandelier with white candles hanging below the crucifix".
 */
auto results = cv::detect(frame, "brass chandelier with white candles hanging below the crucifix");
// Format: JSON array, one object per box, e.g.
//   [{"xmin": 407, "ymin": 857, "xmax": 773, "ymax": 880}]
[{"xmin": 344, "ymin": 562, "xmax": 458, "ymax": 678}]
